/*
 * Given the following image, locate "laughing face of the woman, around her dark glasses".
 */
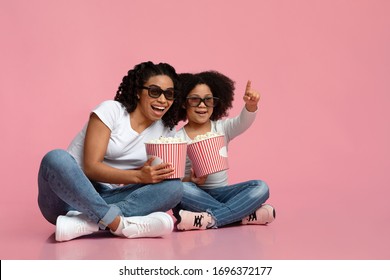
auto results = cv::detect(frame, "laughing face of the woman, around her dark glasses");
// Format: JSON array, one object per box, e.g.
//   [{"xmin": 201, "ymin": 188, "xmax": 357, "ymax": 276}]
[{"xmin": 135, "ymin": 75, "xmax": 174, "ymax": 122}]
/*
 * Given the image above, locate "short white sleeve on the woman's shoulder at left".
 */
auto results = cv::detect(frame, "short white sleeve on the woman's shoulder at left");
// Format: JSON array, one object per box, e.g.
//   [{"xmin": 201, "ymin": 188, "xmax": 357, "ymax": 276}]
[{"xmin": 92, "ymin": 100, "xmax": 124, "ymax": 131}]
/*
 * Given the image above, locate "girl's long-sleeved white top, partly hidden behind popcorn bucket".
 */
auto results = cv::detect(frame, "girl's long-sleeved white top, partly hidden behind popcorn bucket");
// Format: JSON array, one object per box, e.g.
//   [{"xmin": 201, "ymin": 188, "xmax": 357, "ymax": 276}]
[{"xmin": 176, "ymin": 107, "xmax": 257, "ymax": 189}]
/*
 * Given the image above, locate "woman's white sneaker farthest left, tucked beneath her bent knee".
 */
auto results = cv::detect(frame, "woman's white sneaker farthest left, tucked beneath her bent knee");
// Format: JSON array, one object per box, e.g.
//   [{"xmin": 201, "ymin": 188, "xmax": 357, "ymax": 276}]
[{"xmin": 56, "ymin": 211, "xmax": 99, "ymax": 241}]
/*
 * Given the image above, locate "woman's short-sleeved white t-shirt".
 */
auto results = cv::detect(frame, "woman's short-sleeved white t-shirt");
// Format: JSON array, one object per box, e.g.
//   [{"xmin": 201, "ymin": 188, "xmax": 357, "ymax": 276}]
[{"xmin": 68, "ymin": 100, "xmax": 175, "ymax": 187}]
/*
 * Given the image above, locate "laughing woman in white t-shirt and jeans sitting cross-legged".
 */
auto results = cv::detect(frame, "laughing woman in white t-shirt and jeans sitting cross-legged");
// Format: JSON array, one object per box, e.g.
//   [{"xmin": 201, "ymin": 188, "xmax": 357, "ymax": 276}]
[{"xmin": 38, "ymin": 62, "xmax": 182, "ymax": 241}]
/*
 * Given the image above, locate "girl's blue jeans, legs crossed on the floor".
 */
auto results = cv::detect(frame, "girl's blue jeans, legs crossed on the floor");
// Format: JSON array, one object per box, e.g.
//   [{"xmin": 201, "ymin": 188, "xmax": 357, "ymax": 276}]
[{"xmin": 174, "ymin": 180, "xmax": 269, "ymax": 227}]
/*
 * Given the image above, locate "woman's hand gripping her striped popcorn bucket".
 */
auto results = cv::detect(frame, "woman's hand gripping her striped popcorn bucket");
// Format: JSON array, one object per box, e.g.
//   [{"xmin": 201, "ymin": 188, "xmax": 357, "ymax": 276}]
[{"xmin": 139, "ymin": 157, "xmax": 175, "ymax": 184}]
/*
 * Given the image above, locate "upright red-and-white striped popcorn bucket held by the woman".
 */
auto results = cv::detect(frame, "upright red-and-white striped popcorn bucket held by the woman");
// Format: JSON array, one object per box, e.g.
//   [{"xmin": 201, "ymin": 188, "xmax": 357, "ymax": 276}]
[{"xmin": 145, "ymin": 142, "xmax": 187, "ymax": 179}]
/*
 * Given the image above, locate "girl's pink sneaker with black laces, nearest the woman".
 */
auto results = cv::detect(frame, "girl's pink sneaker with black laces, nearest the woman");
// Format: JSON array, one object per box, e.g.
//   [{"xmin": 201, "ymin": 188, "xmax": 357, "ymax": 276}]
[{"xmin": 177, "ymin": 210, "xmax": 212, "ymax": 230}]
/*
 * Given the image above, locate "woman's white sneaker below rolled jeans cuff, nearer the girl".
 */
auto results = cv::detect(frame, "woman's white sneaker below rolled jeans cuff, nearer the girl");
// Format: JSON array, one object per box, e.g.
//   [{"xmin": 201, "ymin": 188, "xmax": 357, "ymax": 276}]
[{"xmin": 122, "ymin": 212, "xmax": 173, "ymax": 238}]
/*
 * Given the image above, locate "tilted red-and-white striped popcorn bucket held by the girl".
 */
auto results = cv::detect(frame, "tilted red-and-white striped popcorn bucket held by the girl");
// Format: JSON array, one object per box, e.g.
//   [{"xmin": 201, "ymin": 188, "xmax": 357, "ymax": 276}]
[{"xmin": 187, "ymin": 135, "xmax": 229, "ymax": 177}]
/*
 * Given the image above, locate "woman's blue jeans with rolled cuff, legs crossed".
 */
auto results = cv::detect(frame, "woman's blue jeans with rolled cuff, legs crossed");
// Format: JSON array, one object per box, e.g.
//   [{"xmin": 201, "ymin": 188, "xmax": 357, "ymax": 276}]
[{"xmin": 38, "ymin": 150, "xmax": 183, "ymax": 229}]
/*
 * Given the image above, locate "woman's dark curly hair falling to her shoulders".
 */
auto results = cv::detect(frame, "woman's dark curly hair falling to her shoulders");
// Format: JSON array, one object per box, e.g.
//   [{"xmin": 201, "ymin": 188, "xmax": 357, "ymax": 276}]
[{"xmin": 114, "ymin": 61, "xmax": 179, "ymax": 130}]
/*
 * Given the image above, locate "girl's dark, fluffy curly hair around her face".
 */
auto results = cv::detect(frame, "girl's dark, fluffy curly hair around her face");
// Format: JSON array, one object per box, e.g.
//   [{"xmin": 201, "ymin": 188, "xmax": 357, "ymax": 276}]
[{"xmin": 178, "ymin": 71, "xmax": 235, "ymax": 121}]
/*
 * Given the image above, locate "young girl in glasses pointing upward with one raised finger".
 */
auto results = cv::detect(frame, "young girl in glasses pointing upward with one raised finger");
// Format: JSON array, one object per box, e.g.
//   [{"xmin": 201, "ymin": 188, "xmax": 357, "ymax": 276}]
[{"xmin": 173, "ymin": 71, "xmax": 275, "ymax": 230}]
